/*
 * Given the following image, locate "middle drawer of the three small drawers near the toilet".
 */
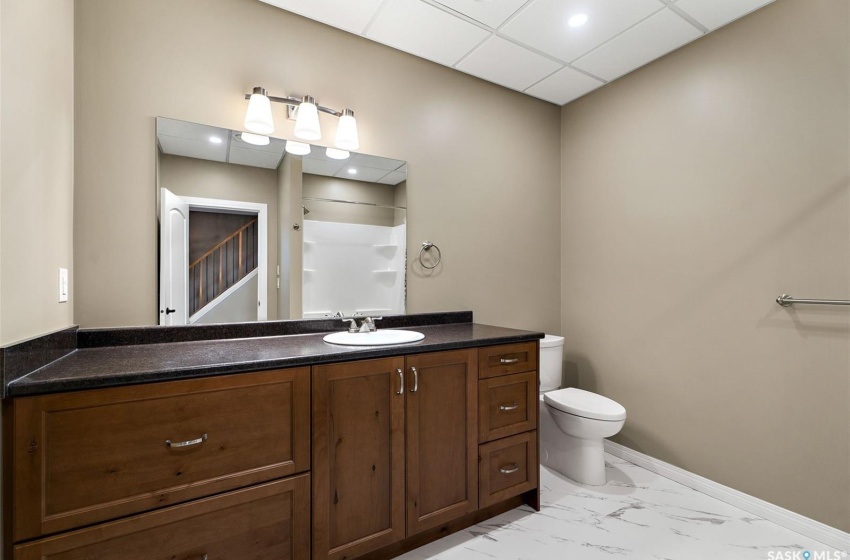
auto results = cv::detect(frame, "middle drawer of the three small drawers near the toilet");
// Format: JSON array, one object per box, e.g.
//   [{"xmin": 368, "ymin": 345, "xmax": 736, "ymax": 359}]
[{"xmin": 478, "ymin": 371, "xmax": 538, "ymax": 443}]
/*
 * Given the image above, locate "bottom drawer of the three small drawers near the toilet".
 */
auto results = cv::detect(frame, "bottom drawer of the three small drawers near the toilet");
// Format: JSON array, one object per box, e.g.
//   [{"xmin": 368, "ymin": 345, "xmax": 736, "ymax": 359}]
[{"xmin": 478, "ymin": 431, "xmax": 538, "ymax": 508}]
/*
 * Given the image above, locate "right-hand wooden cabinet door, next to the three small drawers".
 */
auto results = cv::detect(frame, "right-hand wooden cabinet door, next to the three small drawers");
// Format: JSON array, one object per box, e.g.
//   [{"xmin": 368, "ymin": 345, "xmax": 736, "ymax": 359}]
[{"xmin": 406, "ymin": 349, "xmax": 478, "ymax": 536}]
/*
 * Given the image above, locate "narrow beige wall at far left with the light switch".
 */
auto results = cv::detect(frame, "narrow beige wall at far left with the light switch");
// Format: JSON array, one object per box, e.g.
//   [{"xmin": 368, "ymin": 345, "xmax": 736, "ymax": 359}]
[{"xmin": 0, "ymin": 0, "xmax": 74, "ymax": 344}]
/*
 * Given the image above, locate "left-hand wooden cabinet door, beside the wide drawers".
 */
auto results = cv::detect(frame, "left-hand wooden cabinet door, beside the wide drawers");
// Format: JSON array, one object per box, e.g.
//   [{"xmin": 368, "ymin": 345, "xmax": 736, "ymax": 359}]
[{"xmin": 313, "ymin": 358, "xmax": 405, "ymax": 560}]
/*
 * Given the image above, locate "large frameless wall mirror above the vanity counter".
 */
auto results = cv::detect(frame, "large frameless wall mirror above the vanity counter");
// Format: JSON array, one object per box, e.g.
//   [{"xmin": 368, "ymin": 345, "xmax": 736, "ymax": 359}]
[{"xmin": 156, "ymin": 117, "xmax": 407, "ymax": 325}]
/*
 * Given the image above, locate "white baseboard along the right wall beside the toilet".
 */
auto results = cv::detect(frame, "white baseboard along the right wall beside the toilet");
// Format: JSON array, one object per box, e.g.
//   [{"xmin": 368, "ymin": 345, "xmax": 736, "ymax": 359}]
[{"xmin": 605, "ymin": 440, "xmax": 850, "ymax": 552}]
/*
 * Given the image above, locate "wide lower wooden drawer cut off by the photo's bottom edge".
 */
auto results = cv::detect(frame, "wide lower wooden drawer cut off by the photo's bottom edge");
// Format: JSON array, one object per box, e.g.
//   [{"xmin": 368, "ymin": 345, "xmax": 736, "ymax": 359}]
[{"xmin": 15, "ymin": 475, "xmax": 310, "ymax": 560}]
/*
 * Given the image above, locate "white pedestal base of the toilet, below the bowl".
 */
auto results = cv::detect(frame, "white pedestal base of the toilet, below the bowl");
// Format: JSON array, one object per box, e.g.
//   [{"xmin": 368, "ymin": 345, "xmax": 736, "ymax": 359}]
[{"xmin": 540, "ymin": 403, "xmax": 607, "ymax": 486}]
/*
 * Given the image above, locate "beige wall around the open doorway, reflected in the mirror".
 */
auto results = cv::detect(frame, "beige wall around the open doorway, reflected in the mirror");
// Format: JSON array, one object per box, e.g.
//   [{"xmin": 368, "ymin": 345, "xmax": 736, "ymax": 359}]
[{"xmin": 159, "ymin": 152, "xmax": 278, "ymax": 322}]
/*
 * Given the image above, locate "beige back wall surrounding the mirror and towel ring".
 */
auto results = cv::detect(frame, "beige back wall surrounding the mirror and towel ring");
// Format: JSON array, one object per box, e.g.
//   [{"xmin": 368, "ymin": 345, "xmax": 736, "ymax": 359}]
[{"xmin": 75, "ymin": 0, "xmax": 560, "ymax": 331}]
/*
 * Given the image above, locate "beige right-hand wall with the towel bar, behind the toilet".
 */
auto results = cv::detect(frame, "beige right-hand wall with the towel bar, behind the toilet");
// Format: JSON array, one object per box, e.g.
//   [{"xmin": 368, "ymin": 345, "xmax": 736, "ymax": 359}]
[{"xmin": 561, "ymin": 0, "xmax": 850, "ymax": 531}]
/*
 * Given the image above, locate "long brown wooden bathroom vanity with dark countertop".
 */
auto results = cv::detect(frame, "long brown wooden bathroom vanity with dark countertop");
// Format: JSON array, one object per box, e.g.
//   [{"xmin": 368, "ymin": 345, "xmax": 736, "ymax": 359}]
[{"xmin": 3, "ymin": 315, "xmax": 542, "ymax": 560}]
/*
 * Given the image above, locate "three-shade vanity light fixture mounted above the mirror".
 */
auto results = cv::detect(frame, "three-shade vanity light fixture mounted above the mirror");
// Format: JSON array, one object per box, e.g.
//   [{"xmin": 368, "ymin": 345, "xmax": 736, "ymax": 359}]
[{"xmin": 245, "ymin": 87, "xmax": 360, "ymax": 153}]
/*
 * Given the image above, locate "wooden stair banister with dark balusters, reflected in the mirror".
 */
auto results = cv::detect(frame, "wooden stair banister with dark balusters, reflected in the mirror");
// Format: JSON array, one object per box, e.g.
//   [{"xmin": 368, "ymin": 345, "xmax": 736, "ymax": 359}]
[{"xmin": 189, "ymin": 219, "xmax": 259, "ymax": 316}]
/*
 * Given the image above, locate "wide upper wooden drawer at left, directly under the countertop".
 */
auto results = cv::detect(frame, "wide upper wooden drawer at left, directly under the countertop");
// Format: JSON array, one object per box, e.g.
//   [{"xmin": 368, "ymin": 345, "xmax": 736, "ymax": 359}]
[{"xmin": 12, "ymin": 368, "xmax": 310, "ymax": 541}]
